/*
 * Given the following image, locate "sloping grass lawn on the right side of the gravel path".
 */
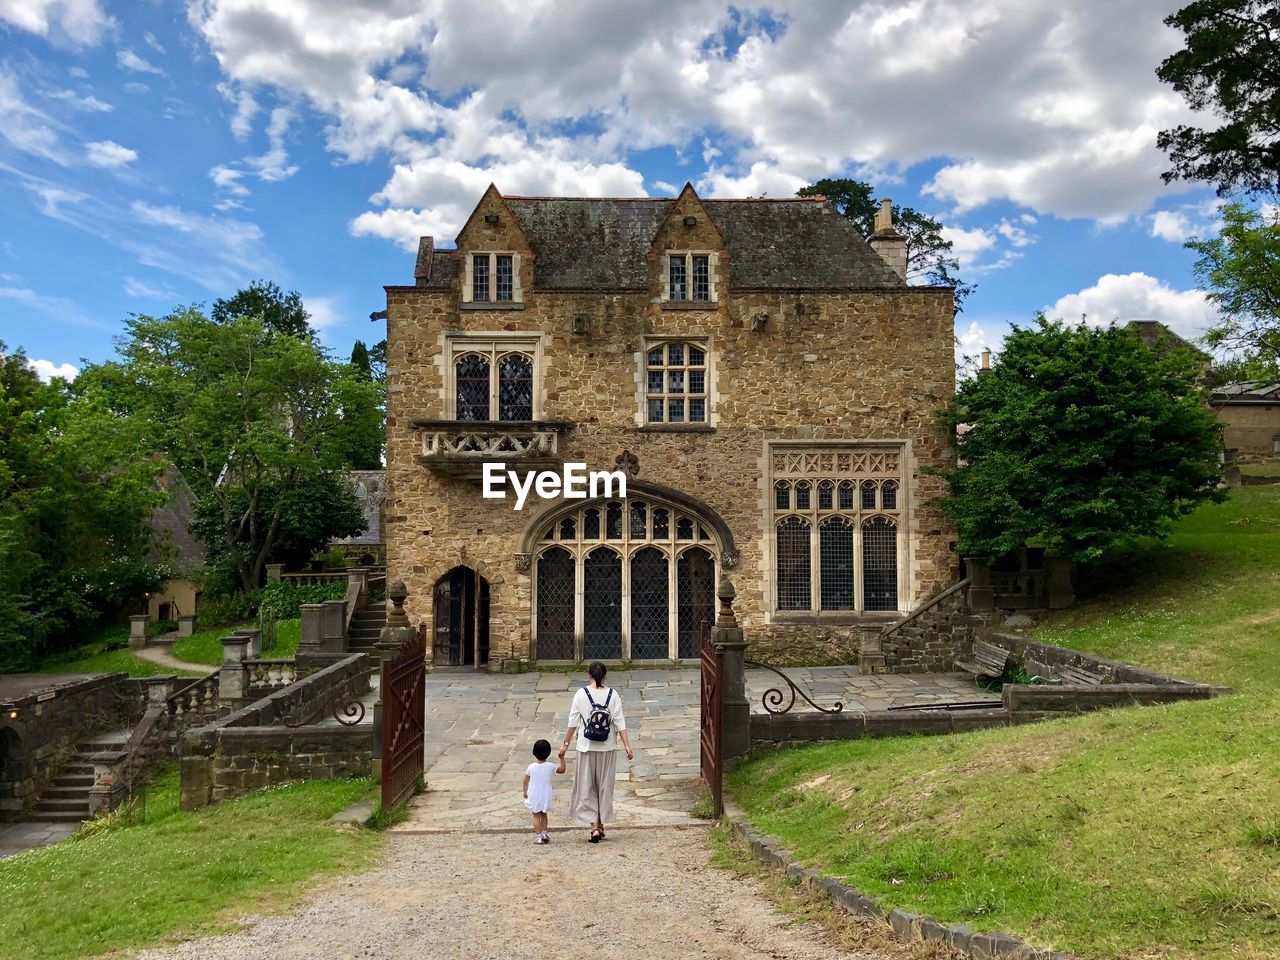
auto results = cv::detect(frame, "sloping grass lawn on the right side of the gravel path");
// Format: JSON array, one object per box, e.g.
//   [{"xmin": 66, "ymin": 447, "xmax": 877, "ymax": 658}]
[{"xmin": 730, "ymin": 486, "xmax": 1280, "ymax": 959}]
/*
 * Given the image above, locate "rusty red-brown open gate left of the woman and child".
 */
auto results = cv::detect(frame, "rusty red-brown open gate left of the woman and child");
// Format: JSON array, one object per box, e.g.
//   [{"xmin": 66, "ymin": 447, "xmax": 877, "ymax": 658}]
[{"xmin": 381, "ymin": 627, "xmax": 426, "ymax": 813}]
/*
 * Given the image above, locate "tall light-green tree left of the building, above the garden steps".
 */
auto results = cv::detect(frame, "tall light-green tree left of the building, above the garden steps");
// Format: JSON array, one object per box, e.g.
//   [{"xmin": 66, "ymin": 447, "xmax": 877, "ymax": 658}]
[{"xmin": 82, "ymin": 307, "xmax": 355, "ymax": 590}]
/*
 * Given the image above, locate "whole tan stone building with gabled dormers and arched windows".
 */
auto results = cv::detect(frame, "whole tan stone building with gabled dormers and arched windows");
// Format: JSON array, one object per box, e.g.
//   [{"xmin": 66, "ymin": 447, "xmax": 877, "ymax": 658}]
[{"xmin": 373, "ymin": 186, "xmax": 956, "ymax": 668}]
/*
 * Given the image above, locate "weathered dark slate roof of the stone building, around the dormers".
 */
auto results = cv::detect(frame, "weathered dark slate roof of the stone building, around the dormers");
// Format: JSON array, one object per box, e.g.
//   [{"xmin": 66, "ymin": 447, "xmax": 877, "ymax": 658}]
[{"xmin": 426, "ymin": 197, "xmax": 904, "ymax": 289}]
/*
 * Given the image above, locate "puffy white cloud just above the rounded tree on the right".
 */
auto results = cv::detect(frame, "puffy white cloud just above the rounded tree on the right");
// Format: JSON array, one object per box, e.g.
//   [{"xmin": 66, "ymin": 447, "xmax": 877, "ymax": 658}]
[{"xmin": 1046, "ymin": 273, "xmax": 1217, "ymax": 339}]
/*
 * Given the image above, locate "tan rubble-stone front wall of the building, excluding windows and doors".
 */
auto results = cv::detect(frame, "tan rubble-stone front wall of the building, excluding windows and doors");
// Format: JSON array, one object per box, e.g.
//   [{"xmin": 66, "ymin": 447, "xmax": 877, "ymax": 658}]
[{"xmin": 385, "ymin": 238, "xmax": 957, "ymax": 662}]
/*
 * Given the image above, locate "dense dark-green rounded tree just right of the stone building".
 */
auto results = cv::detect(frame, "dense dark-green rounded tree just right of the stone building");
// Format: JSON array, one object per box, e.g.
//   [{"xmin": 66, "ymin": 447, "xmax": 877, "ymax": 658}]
[{"xmin": 946, "ymin": 316, "xmax": 1222, "ymax": 562}]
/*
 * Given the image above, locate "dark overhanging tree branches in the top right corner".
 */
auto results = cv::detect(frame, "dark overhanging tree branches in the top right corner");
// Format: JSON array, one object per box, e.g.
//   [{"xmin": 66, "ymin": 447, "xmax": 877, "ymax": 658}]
[{"xmin": 1156, "ymin": 0, "xmax": 1280, "ymax": 195}]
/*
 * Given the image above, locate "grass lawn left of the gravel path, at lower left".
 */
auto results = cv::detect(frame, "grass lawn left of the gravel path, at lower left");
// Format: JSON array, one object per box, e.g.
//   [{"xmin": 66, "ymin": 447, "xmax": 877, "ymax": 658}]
[{"xmin": 0, "ymin": 771, "xmax": 381, "ymax": 960}]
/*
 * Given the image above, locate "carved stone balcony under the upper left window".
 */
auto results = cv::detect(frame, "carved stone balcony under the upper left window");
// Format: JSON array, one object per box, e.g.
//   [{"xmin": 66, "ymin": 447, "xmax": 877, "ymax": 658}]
[{"xmin": 412, "ymin": 420, "xmax": 573, "ymax": 480}]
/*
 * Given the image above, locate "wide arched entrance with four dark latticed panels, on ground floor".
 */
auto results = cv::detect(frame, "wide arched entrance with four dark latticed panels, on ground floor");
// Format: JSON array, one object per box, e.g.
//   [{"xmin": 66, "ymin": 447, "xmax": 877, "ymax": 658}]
[{"xmin": 531, "ymin": 495, "xmax": 722, "ymax": 660}]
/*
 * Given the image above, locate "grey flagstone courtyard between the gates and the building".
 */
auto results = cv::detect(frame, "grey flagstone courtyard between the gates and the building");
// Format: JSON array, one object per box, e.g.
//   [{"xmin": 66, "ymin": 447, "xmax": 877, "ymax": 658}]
[{"xmin": 393, "ymin": 667, "xmax": 982, "ymax": 833}]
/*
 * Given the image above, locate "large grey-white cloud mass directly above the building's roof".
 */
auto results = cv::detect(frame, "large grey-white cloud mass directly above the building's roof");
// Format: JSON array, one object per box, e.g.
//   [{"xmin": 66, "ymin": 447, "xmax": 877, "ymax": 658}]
[{"xmin": 188, "ymin": 0, "xmax": 1189, "ymax": 250}]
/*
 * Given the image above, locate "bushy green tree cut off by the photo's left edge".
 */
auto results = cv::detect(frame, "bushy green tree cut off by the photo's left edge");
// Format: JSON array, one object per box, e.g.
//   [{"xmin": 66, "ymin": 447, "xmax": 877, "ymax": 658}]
[{"xmin": 0, "ymin": 343, "xmax": 164, "ymax": 672}]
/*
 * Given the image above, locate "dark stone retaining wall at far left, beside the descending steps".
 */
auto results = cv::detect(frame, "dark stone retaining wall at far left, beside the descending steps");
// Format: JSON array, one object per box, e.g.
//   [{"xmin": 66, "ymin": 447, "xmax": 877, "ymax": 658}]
[{"xmin": 0, "ymin": 673, "xmax": 142, "ymax": 820}]
